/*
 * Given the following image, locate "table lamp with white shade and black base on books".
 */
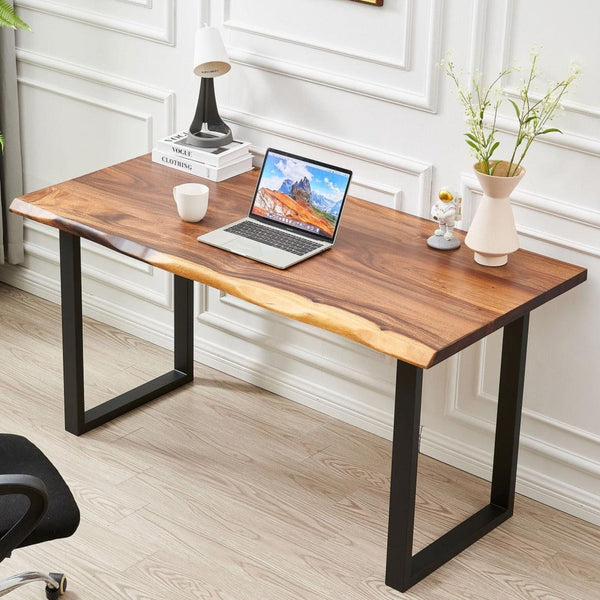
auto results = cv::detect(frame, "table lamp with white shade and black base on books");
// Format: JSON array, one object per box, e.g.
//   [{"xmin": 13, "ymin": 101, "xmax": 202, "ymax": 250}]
[{"xmin": 187, "ymin": 27, "xmax": 233, "ymax": 148}]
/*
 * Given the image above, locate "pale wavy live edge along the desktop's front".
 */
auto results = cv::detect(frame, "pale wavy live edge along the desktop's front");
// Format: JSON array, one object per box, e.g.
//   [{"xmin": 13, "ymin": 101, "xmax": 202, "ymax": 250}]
[{"xmin": 10, "ymin": 198, "xmax": 438, "ymax": 369}]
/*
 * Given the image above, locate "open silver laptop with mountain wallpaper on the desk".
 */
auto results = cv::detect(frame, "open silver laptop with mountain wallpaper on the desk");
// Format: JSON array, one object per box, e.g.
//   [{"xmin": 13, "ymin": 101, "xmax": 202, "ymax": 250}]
[{"xmin": 198, "ymin": 148, "xmax": 352, "ymax": 269}]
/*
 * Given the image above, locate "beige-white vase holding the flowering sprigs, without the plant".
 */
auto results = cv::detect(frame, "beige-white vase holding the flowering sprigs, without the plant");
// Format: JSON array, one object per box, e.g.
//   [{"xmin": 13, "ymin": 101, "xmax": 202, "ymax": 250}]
[{"xmin": 465, "ymin": 161, "xmax": 525, "ymax": 267}]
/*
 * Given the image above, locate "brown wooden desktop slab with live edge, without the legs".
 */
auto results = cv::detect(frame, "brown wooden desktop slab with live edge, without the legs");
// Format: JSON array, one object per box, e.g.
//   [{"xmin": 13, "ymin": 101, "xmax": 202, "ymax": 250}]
[{"xmin": 11, "ymin": 155, "xmax": 587, "ymax": 368}]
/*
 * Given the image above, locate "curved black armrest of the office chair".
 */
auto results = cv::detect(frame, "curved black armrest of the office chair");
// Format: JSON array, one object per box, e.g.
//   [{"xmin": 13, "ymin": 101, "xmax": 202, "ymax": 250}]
[{"xmin": 0, "ymin": 474, "xmax": 48, "ymax": 562}]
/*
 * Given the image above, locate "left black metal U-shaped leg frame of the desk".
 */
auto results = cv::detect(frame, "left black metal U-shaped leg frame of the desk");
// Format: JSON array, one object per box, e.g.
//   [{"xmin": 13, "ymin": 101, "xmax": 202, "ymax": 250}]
[{"xmin": 60, "ymin": 231, "xmax": 194, "ymax": 435}]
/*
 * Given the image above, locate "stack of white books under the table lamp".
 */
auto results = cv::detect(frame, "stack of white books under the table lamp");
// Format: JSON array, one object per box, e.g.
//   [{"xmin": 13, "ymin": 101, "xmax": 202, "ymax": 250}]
[{"xmin": 152, "ymin": 131, "xmax": 252, "ymax": 181}]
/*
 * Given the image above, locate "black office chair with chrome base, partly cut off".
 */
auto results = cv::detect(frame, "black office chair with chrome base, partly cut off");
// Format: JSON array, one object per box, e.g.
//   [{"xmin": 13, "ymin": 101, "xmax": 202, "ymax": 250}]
[{"xmin": 0, "ymin": 433, "xmax": 79, "ymax": 600}]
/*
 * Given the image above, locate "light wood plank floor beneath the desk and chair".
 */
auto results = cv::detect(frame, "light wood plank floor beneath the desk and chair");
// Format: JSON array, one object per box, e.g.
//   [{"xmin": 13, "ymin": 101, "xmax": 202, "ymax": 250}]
[{"xmin": 0, "ymin": 284, "xmax": 600, "ymax": 600}]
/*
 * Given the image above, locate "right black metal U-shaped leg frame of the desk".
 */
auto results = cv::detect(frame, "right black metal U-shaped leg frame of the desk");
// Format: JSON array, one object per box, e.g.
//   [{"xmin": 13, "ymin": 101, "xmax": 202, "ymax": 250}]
[{"xmin": 385, "ymin": 315, "xmax": 529, "ymax": 592}]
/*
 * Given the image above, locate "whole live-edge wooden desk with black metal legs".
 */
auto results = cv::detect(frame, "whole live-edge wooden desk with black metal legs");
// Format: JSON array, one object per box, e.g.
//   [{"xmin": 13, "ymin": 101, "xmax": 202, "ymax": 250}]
[{"xmin": 11, "ymin": 156, "xmax": 587, "ymax": 591}]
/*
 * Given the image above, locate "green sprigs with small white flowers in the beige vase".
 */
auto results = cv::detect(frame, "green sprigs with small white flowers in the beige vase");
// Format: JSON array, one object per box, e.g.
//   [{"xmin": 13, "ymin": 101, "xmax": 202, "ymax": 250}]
[{"xmin": 442, "ymin": 50, "xmax": 580, "ymax": 177}]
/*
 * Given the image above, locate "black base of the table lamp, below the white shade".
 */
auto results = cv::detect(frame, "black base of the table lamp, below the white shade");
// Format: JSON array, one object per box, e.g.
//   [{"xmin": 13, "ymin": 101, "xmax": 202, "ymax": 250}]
[{"xmin": 187, "ymin": 77, "xmax": 233, "ymax": 148}]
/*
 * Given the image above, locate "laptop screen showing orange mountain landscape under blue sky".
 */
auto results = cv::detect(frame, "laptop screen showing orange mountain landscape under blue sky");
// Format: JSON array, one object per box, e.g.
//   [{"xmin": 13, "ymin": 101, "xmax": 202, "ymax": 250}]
[{"xmin": 250, "ymin": 148, "xmax": 352, "ymax": 240}]
